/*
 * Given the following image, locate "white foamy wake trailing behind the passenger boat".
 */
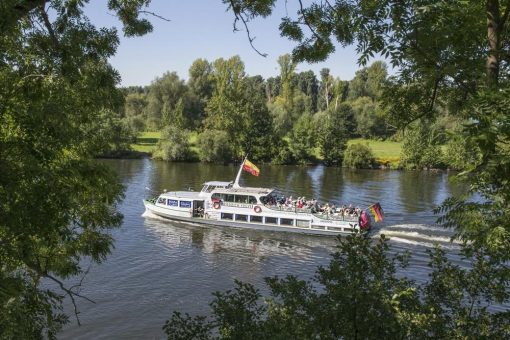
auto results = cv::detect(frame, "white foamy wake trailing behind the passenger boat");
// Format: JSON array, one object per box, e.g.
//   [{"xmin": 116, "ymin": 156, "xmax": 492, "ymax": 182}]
[{"xmin": 372, "ymin": 224, "xmax": 460, "ymax": 248}]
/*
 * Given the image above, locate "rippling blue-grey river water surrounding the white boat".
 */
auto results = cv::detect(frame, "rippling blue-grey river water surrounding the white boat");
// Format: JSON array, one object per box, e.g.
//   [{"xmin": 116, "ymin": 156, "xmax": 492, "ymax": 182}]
[{"xmin": 59, "ymin": 159, "xmax": 470, "ymax": 339}]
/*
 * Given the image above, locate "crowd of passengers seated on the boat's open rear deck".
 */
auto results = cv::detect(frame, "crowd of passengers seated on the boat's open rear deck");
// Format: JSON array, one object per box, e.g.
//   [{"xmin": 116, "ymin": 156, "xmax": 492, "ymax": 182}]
[{"xmin": 263, "ymin": 196, "xmax": 361, "ymax": 217}]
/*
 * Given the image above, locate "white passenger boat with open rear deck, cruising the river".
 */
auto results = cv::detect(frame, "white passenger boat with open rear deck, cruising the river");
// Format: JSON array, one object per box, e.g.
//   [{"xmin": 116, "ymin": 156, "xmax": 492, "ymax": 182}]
[{"xmin": 144, "ymin": 159, "xmax": 380, "ymax": 235}]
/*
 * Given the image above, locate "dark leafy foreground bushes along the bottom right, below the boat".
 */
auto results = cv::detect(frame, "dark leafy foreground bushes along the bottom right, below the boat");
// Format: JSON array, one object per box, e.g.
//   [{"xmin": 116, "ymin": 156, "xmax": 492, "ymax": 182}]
[{"xmin": 164, "ymin": 235, "xmax": 510, "ymax": 339}]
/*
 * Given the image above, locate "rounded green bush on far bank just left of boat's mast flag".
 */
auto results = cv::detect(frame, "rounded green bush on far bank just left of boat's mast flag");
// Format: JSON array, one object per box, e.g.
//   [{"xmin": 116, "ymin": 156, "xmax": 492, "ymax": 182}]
[{"xmin": 197, "ymin": 130, "xmax": 233, "ymax": 163}]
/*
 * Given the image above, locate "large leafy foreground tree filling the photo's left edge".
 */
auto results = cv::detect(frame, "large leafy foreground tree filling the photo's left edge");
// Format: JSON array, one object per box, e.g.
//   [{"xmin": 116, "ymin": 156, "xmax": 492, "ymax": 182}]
[{"xmin": 0, "ymin": 0, "xmax": 152, "ymax": 339}]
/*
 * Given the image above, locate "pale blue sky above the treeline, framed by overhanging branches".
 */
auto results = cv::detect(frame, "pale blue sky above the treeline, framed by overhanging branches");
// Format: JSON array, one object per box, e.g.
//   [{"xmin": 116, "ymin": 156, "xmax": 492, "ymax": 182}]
[{"xmin": 85, "ymin": 0, "xmax": 375, "ymax": 86}]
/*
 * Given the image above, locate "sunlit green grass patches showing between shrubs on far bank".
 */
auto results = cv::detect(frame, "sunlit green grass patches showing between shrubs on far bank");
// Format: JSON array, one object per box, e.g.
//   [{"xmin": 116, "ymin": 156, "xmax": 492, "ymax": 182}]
[{"xmin": 131, "ymin": 131, "xmax": 402, "ymax": 166}]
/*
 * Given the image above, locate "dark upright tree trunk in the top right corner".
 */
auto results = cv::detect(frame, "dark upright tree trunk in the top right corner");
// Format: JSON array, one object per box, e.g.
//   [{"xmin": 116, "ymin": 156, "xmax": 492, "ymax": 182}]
[{"xmin": 486, "ymin": 0, "xmax": 502, "ymax": 87}]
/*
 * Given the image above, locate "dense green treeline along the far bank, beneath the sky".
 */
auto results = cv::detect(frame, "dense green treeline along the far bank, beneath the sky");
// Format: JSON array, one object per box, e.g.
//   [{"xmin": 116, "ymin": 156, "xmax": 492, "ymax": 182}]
[{"xmin": 112, "ymin": 55, "xmax": 462, "ymax": 168}]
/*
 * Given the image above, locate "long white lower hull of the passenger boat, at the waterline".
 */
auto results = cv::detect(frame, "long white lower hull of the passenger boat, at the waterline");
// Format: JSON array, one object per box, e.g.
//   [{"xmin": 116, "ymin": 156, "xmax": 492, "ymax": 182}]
[{"xmin": 144, "ymin": 201, "xmax": 359, "ymax": 236}]
